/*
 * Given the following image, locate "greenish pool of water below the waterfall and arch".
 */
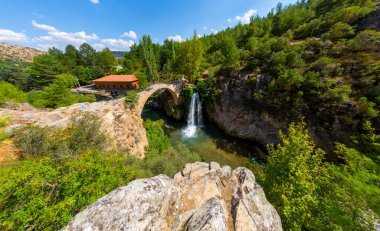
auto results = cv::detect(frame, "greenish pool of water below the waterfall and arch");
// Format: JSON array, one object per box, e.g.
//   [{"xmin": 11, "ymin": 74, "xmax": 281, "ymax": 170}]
[{"xmin": 142, "ymin": 109, "xmax": 261, "ymax": 174}]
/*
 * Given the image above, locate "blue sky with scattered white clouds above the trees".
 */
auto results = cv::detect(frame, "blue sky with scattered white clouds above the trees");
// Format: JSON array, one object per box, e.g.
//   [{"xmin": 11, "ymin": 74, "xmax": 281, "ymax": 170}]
[{"xmin": 0, "ymin": 0, "xmax": 296, "ymax": 51}]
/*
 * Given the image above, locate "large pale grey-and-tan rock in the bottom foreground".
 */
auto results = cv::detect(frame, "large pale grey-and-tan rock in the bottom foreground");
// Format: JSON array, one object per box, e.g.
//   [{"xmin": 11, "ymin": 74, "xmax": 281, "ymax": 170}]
[{"xmin": 63, "ymin": 162, "xmax": 282, "ymax": 231}]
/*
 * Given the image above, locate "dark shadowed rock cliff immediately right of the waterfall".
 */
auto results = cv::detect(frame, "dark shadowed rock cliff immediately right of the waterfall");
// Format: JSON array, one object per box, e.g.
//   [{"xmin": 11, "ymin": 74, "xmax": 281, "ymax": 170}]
[{"xmin": 205, "ymin": 76, "xmax": 288, "ymax": 145}]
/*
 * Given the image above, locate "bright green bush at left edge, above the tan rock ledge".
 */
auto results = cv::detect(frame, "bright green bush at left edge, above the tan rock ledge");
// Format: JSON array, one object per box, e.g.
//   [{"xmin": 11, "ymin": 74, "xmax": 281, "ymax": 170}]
[{"xmin": 0, "ymin": 81, "xmax": 27, "ymax": 105}]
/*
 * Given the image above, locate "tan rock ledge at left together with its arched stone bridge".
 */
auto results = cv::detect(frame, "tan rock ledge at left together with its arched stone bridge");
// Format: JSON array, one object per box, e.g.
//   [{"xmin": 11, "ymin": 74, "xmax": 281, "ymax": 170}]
[{"xmin": 0, "ymin": 80, "xmax": 185, "ymax": 158}]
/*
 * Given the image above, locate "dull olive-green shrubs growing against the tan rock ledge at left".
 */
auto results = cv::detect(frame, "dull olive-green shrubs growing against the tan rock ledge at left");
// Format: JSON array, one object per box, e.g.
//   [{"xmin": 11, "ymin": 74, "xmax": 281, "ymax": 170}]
[{"xmin": 14, "ymin": 114, "xmax": 106, "ymax": 158}]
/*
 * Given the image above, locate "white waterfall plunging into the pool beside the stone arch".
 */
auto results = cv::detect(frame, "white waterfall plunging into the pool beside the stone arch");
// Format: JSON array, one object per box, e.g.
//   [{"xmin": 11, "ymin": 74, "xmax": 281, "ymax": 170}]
[{"xmin": 182, "ymin": 92, "xmax": 203, "ymax": 138}]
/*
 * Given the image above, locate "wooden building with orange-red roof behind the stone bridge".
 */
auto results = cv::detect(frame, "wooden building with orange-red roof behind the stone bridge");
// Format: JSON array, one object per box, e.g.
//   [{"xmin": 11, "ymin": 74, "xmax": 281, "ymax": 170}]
[{"xmin": 93, "ymin": 75, "xmax": 140, "ymax": 90}]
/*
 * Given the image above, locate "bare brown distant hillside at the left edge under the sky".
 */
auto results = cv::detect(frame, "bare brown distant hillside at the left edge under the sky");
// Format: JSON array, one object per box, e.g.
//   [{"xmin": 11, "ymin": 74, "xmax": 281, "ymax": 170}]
[{"xmin": 0, "ymin": 42, "xmax": 46, "ymax": 62}]
